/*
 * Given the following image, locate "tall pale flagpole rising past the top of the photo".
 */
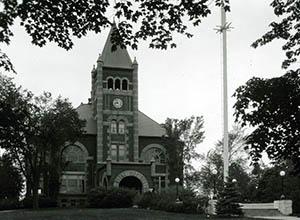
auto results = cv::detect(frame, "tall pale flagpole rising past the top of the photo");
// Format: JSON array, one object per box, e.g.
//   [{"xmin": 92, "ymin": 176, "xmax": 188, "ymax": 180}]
[{"xmin": 221, "ymin": 0, "xmax": 229, "ymax": 182}]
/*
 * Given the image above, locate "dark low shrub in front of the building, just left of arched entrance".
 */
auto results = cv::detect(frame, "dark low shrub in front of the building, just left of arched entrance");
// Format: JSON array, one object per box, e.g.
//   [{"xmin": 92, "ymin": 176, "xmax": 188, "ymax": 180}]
[{"xmin": 88, "ymin": 188, "xmax": 136, "ymax": 208}]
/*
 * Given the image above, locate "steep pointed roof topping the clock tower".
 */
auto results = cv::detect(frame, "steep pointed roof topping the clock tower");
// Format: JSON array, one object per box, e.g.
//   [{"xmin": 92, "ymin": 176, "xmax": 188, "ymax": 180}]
[{"xmin": 102, "ymin": 24, "xmax": 132, "ymax": 68}]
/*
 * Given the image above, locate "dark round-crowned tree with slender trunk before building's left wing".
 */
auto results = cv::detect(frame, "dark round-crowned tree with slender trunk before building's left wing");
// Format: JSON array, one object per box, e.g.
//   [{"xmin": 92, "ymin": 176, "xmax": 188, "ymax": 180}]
[{"xmin": 40, "ymin": 97, "xmax": 84, "ymax": 200}]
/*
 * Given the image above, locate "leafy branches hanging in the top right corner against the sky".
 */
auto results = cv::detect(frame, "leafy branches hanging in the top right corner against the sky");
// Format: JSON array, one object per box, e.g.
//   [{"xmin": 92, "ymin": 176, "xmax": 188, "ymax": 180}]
[{"xmin": 252, "ymin": 0, "xmax": 300, "ymax": 69}]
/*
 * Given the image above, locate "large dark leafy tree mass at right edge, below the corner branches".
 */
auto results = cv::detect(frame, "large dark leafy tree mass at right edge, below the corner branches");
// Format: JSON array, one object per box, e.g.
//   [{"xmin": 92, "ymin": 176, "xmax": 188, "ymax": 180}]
[{"xmin": 234, "ymin": 70, "xmax": 300, "ymax": 174}]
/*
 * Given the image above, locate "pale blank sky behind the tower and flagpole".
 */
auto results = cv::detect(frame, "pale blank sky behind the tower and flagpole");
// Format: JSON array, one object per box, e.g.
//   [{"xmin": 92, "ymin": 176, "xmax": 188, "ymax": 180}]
[{"xmin": 2, "ymin": 0, "xmax": 284, "ymax": 165}]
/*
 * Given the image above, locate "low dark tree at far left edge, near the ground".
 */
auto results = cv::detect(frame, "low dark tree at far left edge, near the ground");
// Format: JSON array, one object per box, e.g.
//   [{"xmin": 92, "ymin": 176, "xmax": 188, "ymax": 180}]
[{"xmin": 0, "ymin": 154, "xmax": 24, "ymax": 200}]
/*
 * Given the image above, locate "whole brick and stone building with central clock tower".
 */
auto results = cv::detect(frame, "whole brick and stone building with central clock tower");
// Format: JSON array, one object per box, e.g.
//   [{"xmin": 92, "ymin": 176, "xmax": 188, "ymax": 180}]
[{"xmin": 59, "ymin": 27, "xmax": 169, "ymax": 206}]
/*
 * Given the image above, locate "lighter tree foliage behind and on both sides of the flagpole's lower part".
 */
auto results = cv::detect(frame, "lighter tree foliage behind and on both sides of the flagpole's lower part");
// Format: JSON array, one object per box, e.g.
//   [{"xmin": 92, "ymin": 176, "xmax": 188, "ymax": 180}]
[{"xmin": 194, "ymin": 125, "xmax": 250, "ymax": 200}]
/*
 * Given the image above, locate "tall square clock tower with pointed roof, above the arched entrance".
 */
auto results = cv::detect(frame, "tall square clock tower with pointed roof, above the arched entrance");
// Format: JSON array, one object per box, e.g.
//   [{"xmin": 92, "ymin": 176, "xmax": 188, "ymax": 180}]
[{"xmin": 91, "ymin": 26, "xmax": 139, "ymax": 164}]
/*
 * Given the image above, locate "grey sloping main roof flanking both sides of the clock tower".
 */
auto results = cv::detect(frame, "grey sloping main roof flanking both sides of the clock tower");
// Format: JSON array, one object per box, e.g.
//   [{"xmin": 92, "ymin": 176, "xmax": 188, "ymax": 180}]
[{"xmin": 76, "ymin": 104, "xmax": 166, "ymax": 137}]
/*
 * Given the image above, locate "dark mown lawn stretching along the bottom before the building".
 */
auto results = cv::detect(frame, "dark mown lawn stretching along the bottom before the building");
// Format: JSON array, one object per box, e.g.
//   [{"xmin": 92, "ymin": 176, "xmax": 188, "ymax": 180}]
[{"xmin": 0, "ymin": 209, "xmax": 268, "ymax": 220}]
